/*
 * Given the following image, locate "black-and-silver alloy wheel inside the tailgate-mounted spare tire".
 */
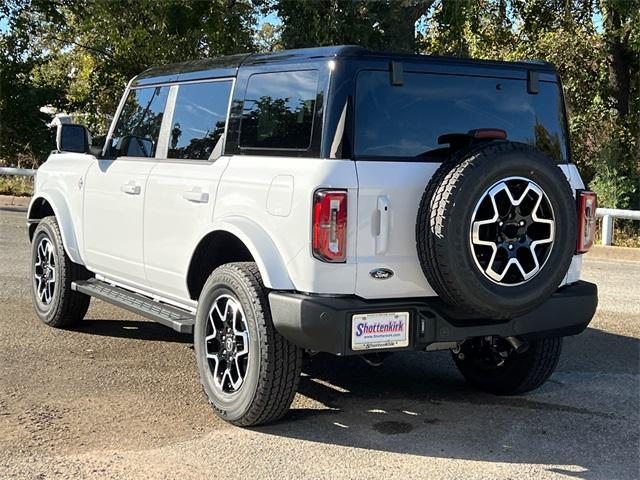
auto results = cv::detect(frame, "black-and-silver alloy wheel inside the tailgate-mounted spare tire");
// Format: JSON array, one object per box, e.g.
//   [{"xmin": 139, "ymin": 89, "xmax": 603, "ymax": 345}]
[{"xmin": 470, "ymin": 177, "xmax": 555, "ymax": 286}]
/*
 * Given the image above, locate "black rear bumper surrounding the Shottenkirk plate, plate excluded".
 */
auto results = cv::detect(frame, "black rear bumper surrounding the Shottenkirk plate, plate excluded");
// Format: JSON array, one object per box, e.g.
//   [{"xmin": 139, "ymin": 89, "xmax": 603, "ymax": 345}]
[{"xmin": 269, "ymin": 281, "xmax": 598, "ymax": 355}]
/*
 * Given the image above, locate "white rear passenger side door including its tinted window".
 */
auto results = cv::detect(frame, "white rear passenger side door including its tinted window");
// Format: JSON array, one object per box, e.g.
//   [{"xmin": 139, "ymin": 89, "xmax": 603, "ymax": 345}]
[{"xmin": 144, "ymin": 78, "xmax": 233, "ymax": 300}]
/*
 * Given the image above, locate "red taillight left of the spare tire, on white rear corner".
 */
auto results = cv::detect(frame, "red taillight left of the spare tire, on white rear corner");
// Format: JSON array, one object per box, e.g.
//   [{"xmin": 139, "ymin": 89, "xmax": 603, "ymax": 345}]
[{"xmin": 312, "ymin": 190, "xmax": 347, "ymax": 262}]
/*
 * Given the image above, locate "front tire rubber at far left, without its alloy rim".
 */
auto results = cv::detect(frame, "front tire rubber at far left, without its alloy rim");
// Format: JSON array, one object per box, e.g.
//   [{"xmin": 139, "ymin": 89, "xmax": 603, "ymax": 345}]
[{"xmin": 31, "ymin": 216, "xmax": 91, "ymax": 328}]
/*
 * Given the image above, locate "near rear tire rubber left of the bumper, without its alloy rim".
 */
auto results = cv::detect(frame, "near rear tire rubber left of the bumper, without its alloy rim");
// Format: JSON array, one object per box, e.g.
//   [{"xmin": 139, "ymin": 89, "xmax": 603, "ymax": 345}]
[{"xmin": 194, "ymin": 262, "xmax": 302, "ymax": 427}]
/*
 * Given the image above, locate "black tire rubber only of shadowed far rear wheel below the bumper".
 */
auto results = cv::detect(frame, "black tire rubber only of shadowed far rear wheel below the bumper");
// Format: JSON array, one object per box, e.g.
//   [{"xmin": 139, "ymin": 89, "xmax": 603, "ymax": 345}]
[{"xmin": 453, "ymin": 337, "xmax": 562, "ymax": 395}]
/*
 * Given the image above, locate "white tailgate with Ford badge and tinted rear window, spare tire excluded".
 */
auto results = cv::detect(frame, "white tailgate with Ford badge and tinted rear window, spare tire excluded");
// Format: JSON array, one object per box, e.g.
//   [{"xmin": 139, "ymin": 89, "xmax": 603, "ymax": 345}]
[{"xmin": 354, "ymin": 62, "xmax": 567, "ymax": 298}]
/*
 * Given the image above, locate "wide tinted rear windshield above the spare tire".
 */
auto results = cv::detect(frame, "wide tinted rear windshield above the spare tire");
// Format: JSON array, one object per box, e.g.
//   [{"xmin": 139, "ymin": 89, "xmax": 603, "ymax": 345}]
[{"xmin": 354, "ymin": 70, "xmax": 567, "ymax": 162}]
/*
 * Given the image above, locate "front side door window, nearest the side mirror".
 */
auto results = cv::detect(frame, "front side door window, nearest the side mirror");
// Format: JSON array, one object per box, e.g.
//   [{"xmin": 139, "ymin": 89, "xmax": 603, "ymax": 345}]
[{"xmin": 111, "ymin": 87, "xmax": 169, "ymax": 157}]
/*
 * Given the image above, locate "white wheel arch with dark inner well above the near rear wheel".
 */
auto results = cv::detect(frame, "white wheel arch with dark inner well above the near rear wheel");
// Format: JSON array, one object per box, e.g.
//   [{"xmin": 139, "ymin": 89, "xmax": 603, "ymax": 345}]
[{"xmin": 186, "ymin": 217, "xmax": 295, "ymax": 300}]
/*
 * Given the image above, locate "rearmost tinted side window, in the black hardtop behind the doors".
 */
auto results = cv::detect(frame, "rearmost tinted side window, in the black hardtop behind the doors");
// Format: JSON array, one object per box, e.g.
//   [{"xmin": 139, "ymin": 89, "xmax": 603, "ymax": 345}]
[{"xmin": 240, "ymin": 70, "xmax": 318, "ymax": 150}]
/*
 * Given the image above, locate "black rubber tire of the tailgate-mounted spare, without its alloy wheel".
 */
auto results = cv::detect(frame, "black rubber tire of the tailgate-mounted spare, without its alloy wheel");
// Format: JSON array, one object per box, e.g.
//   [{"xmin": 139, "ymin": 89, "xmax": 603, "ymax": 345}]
[{"xmin": 416, "ymin": 141, "xmax": 577, "ymax": 319}]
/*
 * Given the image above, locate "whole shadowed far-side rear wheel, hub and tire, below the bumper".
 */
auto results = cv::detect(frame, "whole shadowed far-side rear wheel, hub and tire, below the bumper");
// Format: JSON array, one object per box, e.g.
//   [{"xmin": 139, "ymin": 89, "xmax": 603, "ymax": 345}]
[{"xmin": 453, "ymin": 337, "xmax": 562, "ymax": 395}]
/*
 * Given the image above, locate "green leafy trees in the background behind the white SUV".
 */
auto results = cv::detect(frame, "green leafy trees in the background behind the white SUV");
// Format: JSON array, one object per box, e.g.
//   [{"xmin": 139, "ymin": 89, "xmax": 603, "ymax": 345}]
[{"xmin": 0, "ymin": 0, "xmax": 640, "ymax": 216}]
